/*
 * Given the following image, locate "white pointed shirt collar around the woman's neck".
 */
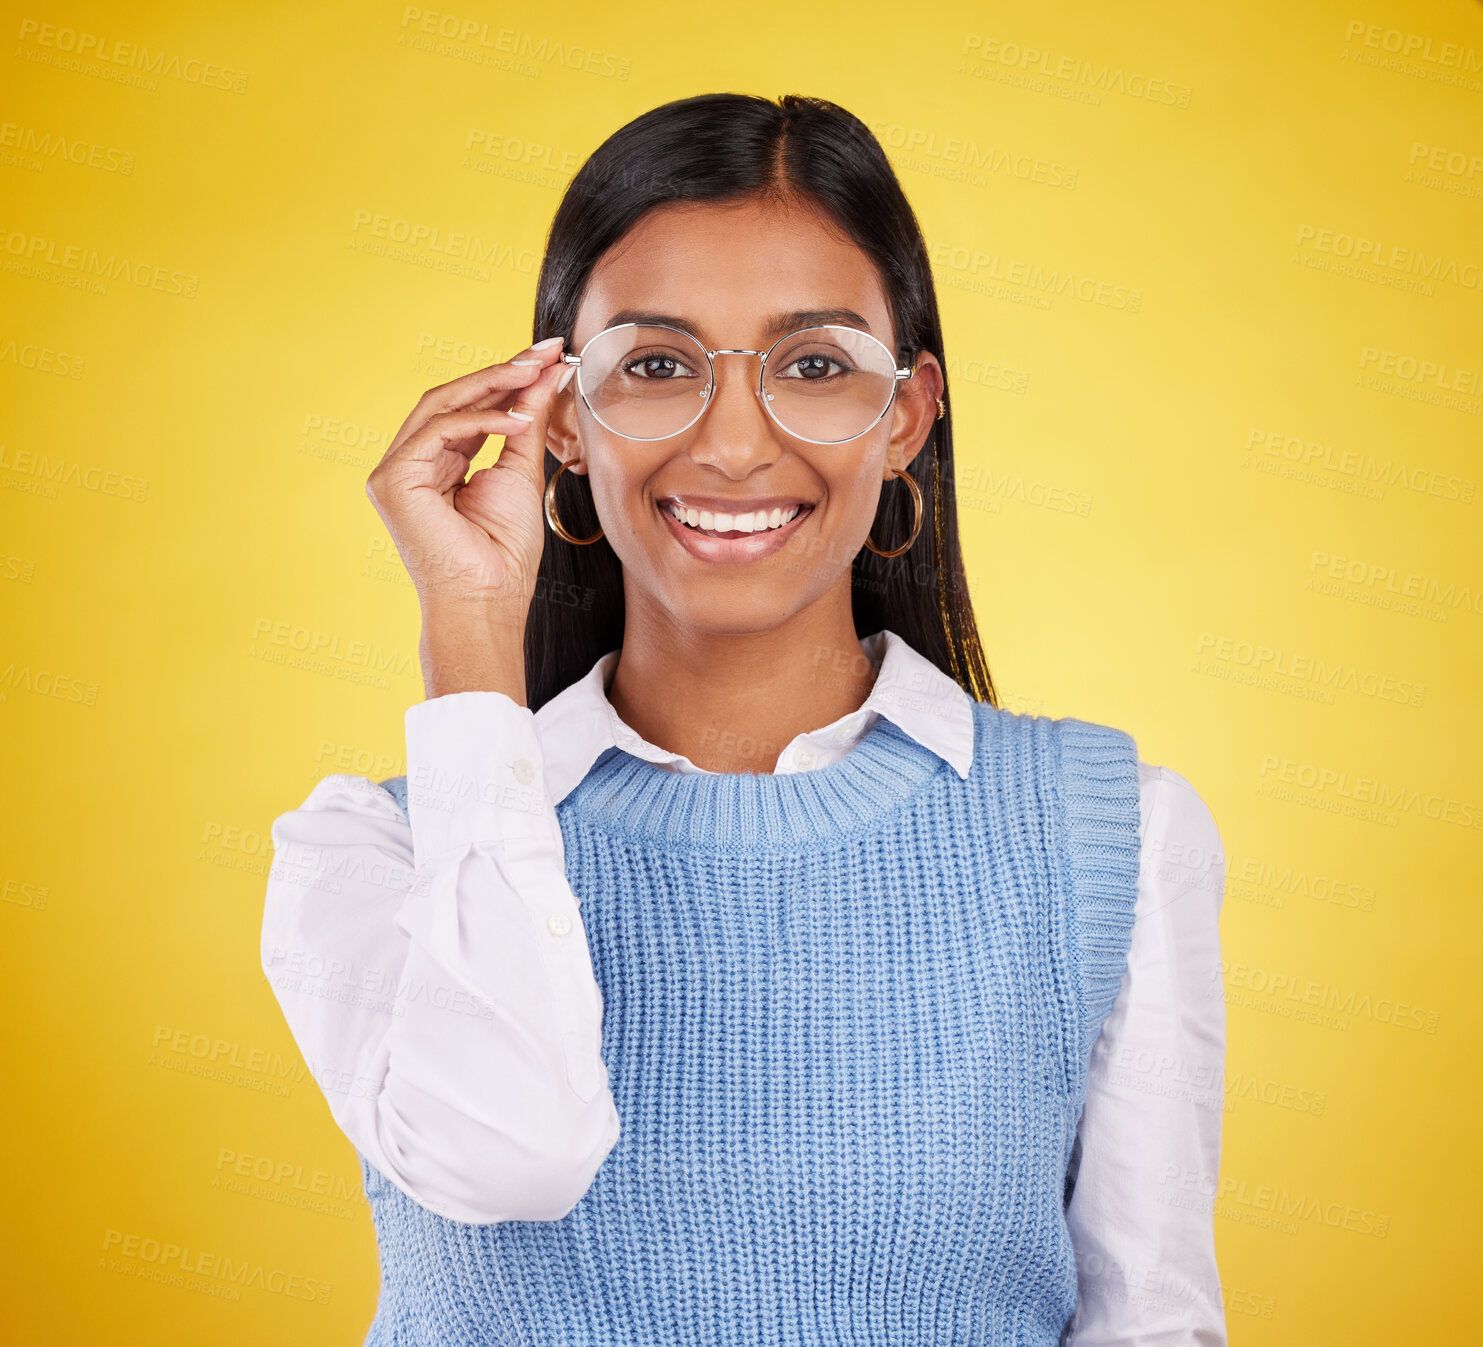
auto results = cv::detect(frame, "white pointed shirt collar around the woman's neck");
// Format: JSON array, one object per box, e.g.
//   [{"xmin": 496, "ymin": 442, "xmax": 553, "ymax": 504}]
[{"xmin": 535, "ymin": 630, "xmax": 973, "ymax": 804}]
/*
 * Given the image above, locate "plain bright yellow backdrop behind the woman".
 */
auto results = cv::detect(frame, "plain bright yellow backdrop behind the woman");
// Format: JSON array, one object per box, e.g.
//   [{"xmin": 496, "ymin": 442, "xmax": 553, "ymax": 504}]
[{"xmin": 0, "ymin": 0, "xmax": 1483, "ymax": 1347}]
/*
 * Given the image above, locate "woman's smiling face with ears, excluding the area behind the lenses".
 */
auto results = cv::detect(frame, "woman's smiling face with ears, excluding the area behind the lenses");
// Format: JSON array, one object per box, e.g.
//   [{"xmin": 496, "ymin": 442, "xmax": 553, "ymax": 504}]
[{"xmin": 547, "ymin": 191, "xmax": 943, "ymax": 633}]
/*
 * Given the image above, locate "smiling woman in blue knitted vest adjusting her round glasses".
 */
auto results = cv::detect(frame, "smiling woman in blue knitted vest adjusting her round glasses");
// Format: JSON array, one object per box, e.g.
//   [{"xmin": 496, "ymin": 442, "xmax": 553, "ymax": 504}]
[{"xmin": 262, "ymin": 95, "xmax": 1225, "ymax": 1344}]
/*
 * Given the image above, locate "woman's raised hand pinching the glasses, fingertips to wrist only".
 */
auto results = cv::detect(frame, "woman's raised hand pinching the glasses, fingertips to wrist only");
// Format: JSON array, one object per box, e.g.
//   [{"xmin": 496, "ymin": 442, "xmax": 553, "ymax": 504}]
[{"xmin": 366, "ymin": 337, "xmax": 572, "ymax": 622}]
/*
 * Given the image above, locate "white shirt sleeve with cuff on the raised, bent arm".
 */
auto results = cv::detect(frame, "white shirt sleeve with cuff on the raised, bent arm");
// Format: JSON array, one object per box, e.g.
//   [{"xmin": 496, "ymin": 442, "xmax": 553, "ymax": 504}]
[{"xmin": 262, "ymin": 691, "xmax": 618, "ymax": 1224}]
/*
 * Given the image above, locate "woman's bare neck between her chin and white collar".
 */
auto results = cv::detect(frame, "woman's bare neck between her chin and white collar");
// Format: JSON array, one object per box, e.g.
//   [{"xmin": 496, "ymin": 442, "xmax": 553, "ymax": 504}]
[{"xmin": 608, "ymin": 586, "xmax": 878, "ymax": 773}]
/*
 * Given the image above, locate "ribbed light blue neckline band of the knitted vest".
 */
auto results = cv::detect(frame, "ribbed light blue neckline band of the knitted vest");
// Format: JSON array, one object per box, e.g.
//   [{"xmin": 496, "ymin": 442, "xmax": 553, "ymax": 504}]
[{"xmin": 559, "ymin": 715, "xmax": 960, "ymax": 853}]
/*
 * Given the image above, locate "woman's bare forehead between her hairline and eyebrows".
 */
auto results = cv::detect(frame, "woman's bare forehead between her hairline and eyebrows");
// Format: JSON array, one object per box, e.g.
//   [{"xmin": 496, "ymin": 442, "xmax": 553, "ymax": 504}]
[{"xmin": 572, "ymin": 200, "xmax": 894, "ymax": 349}]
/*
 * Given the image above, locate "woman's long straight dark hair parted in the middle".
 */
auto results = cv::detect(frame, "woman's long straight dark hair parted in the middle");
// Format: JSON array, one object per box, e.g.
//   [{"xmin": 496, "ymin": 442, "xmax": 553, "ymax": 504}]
[{"xmin": 525, "ymin": 93, "xmax": 998, "ymax": 711}]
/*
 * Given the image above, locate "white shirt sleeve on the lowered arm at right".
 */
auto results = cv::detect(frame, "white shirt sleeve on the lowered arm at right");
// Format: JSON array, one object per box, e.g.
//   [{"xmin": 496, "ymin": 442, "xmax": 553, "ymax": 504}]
[{"xmin": 1066, "ymin": 763, "xmax": 1226, "ymax": 1347}]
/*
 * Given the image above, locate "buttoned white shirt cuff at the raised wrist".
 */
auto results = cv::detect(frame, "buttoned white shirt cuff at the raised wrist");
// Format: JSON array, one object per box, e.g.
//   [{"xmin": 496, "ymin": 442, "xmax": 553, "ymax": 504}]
[{"xmin": 406, "ymin": 691, "xmax": 556, "ymax": 865}]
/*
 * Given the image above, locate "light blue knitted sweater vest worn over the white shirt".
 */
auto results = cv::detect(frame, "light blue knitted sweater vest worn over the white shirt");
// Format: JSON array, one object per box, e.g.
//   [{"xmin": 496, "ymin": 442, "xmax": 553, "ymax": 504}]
[{"xmin": 362, "ymin": 702, "xmax": 1139, "ymax": 1347}]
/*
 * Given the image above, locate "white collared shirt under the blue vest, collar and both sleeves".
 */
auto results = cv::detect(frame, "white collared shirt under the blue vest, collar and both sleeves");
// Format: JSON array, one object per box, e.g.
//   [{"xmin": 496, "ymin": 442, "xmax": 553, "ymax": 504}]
[{"xmin": 262, "ymin": 630, "xmax": 1226, "ymax": 1347}]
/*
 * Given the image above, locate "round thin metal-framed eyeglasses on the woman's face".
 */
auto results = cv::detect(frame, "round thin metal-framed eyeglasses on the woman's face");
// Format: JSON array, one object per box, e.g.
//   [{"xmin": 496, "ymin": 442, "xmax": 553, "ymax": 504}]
[{"xmin": 562, "ymin": 323, "xmax": 915, "ymax": 445}]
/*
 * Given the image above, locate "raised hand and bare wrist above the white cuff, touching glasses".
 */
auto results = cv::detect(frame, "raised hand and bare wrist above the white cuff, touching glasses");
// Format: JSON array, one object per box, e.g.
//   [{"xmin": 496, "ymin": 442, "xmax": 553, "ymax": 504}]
[{"xmin": 366, "ymin": 338, "xmax": 574, "ymax": 706}]
